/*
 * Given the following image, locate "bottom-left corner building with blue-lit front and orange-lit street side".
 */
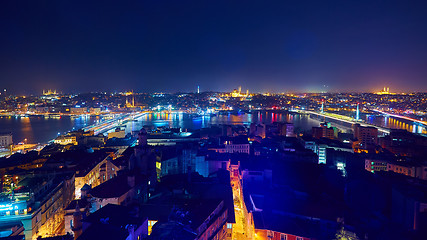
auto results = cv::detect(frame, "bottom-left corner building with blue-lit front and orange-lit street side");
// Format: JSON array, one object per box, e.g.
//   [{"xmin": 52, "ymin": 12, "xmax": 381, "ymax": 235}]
[{"xmin": 0, "ymin": 174, "xmax": 74, "ymax": 240}]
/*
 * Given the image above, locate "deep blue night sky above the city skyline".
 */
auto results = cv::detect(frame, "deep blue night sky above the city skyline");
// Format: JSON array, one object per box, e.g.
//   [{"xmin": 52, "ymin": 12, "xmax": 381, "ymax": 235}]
[{"xmin": 0, "ymin": 0, "xmax": 427, "ymax": 93}]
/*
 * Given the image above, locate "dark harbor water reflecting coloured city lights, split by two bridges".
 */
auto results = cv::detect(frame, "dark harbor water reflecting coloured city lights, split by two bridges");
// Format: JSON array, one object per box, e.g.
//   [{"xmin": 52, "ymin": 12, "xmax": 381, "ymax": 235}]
[{"xmin": 0, "ymin": 111, "xmax": 427, "ymax": 144}]
